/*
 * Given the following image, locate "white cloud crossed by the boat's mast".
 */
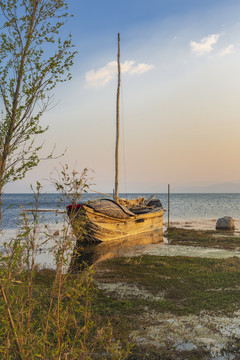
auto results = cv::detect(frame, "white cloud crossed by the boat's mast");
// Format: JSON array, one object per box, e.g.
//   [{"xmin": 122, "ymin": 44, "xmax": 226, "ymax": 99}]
[{"xmin": 85, "ymin": 60, "xmax": 153, "ymax": 87}]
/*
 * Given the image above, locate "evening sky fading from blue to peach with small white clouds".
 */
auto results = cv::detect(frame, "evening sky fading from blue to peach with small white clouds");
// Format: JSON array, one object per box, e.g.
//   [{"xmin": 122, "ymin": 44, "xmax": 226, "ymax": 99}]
[{"xmin": 6, "ymin": 0, "xmax": 240, "ymax": 193}]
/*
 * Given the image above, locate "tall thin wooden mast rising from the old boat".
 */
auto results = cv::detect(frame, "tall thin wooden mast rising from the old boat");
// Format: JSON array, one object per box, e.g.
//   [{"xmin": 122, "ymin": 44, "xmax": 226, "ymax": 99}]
[{"xmin": 114, "ymin": 33, "xmax": 121, "ymax": 201}]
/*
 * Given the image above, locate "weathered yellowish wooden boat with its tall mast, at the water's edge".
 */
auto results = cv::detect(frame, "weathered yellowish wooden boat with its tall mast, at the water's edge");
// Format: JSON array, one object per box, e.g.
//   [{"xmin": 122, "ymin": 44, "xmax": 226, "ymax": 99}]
[{"xmin": 67, "ymin": 34, "xmax": 164, "ymax": 243}]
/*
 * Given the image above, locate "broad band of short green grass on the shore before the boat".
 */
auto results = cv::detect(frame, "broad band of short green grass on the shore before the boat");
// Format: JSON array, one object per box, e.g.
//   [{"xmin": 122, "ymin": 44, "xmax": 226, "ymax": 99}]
[{"xmin": 95, "ymin": 256, "xmax": 240, "ymax": 316}]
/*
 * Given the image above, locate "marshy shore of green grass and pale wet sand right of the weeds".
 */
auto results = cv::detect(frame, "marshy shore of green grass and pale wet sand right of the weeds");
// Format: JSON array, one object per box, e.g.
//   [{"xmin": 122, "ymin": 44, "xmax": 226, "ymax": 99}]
[{"xmin": 0, "ymin": 220, "xmax": 240, "ymax": 360}]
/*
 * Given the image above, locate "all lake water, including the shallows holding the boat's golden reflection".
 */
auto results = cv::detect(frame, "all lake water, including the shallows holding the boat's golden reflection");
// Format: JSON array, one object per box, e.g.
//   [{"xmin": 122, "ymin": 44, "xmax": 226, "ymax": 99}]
[{"xmin": 0, "ymin": 194, "xmax": 240, "ymax": 267}]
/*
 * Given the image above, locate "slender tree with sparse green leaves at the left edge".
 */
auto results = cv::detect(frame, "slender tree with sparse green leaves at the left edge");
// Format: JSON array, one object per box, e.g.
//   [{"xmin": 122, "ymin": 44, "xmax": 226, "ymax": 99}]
[{"xmin": 0, "ymin": 0, "xmax": 76, "ymax": 221}]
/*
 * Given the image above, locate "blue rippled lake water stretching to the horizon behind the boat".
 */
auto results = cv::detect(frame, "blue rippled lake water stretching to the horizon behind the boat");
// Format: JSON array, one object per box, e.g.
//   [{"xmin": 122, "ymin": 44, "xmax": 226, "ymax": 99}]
[{"xmin": 2, "ymin": 194, "xmax": 240, "ymax": 229}]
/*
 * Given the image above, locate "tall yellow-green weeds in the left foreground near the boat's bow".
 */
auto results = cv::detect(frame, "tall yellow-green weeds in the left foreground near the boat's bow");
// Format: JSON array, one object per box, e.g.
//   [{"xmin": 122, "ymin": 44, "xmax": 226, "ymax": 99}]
[{"xmin": 0, "ymin": 168, "xmax": 130, "ymax": 360}]
